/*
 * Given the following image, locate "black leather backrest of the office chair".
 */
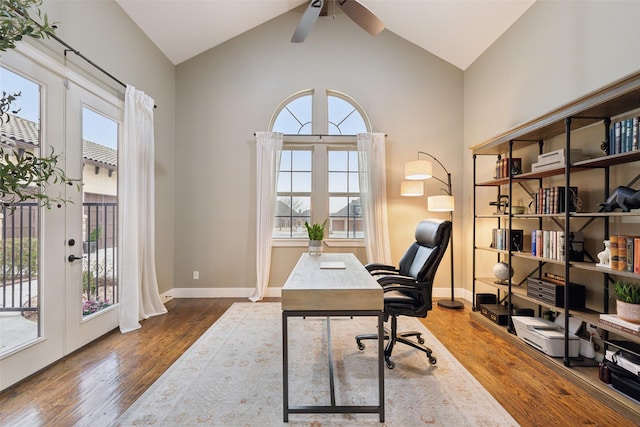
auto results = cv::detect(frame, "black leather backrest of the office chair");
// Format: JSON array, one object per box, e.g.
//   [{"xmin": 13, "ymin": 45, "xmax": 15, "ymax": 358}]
[{"xmin": 398, "ymin": 219, "xmax": 451, "ymax": 287}]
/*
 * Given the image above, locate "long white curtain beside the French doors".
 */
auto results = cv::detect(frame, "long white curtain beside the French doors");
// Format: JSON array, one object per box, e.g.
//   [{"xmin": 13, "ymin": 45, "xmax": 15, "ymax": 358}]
[{"xmin": 118, "ymin": 86, "xmax": 167, "ymax": 333}]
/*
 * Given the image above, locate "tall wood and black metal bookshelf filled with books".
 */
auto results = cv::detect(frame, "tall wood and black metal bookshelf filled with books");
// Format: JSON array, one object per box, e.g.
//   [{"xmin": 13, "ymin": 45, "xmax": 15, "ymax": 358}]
[{"xmin": 471, "ymin": 73, "xmax": 640, "ymax": 411}]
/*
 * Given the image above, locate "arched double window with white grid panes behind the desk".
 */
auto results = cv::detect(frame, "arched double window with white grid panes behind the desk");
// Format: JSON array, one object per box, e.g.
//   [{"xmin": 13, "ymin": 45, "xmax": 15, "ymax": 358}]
[{"xmin": 271, "ymin": 90, "xmax": 371, "ymax": 240}]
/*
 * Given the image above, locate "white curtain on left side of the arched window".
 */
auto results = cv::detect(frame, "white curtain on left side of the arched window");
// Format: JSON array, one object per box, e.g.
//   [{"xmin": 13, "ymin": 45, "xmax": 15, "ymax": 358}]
[{"xmin": 249, "ymin": 132, "xmax": 283, "ymax": 302}]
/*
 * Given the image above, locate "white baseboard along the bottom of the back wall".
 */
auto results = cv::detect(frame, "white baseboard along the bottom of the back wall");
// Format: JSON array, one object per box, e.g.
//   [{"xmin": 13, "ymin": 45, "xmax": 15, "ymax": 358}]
[{"xmin": 160, "ymin": 287, "xmax": 472, "ymax": 303}]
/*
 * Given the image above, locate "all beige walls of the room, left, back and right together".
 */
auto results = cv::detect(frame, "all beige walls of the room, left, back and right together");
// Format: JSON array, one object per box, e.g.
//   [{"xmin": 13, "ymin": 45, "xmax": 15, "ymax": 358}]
[{"xmin": 33, "ymin": 0, "xmax": 640, "ymax": 300}]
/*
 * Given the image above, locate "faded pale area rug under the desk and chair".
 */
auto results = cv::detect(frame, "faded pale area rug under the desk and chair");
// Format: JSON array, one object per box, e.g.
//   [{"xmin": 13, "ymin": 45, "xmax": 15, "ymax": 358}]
[{"xmin": 116, "ymin": 302, "xmax": 517, "ymax": 427}]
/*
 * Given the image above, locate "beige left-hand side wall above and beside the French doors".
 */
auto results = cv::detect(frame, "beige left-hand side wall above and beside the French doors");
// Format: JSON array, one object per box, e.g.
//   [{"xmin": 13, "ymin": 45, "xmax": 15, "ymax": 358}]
[{"xmin": 43, "ymin": 0, "xmax": 175, "ymax": 292}]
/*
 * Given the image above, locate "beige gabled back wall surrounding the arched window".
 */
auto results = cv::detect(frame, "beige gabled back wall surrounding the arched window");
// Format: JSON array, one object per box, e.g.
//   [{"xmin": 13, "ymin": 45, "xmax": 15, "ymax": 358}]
[{"xmin": 175, "ymin": 11, "xmax": 463, "ymax": 288}]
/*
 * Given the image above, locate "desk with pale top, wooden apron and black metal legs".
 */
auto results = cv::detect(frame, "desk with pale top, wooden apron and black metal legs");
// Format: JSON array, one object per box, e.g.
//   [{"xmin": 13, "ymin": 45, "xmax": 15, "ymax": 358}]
[{"xmin": 282, "ymin": 253, "xmax": 384, "ymax": 422}]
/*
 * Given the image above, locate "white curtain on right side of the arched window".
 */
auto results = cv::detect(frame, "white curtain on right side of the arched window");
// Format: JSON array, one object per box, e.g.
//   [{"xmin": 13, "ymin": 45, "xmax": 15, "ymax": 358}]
[{"xmin": 357, "ymin": 133, "xmax": 391, "ymax": 264}]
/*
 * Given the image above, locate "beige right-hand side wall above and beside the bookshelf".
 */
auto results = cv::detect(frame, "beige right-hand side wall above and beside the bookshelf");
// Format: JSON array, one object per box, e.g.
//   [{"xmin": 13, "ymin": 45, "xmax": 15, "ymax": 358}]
[{"xmin": 463, "ymin": 1, "xmax": 640, "ymax": 298}]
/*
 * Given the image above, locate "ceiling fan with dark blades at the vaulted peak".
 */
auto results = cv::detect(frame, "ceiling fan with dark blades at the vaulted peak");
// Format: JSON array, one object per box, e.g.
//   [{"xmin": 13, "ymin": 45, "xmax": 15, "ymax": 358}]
[{"xmin": 291, "ymin": 0, "xmax": 384, "ymax": 43}]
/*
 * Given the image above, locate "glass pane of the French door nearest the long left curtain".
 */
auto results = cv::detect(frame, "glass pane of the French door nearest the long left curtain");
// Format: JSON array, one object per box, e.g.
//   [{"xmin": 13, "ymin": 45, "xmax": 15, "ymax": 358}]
[{"xmin": 82, "ymin": 107, "xmax": 118, "ymax": 316}]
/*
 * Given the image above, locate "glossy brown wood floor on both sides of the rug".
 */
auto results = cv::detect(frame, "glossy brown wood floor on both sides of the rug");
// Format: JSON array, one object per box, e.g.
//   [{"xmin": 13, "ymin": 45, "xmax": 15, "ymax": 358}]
[{"xmin": 0, "ymin": 299, "xmax": 640, "ymax": 427}]
